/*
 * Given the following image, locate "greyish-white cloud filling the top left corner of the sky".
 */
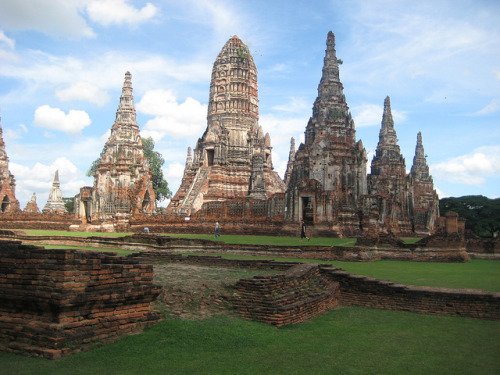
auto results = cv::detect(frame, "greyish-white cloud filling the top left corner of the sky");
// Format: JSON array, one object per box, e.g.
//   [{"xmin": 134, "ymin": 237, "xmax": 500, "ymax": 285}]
[{"xmin": 0, "ymin": 0, "xmax": 95, "ymax": 38}]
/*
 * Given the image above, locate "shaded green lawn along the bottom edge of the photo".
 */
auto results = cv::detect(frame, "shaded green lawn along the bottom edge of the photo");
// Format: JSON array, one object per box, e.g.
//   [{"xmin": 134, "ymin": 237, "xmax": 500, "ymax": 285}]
[{"xmin": 0, "ymin": 307, "xmax": 500, "ymax": 375}]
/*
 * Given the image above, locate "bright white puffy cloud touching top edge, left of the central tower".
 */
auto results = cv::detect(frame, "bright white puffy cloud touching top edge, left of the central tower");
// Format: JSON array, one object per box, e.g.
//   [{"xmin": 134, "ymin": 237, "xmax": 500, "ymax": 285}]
[{"xmin": 87, "ymin": 0, "xmax": 159, "ymax": 26}]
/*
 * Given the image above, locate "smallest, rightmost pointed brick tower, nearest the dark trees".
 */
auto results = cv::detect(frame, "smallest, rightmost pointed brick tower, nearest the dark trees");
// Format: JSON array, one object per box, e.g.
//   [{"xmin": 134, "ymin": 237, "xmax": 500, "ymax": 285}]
[{"xmin": 408, "ymin": 132, "xmax": 439, "ymax": 234}]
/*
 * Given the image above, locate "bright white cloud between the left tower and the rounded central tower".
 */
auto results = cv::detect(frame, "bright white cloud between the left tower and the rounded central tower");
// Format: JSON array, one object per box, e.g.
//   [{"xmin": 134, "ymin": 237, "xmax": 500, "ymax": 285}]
[{"xmin": 136, "ymin": 90, "xmax": 207, "ymax": 141}]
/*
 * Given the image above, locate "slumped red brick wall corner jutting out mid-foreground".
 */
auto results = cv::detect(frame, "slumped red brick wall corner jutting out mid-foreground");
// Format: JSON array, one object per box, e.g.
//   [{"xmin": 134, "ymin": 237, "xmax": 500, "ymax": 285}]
[{"xmin": 231, "ymin": 264, "xmax": 339, "ymax": 326}]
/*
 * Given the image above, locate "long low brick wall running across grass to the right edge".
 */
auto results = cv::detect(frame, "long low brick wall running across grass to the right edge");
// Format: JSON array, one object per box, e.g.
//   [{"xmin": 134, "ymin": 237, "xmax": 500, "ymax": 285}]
[{"xmin": 321, "ymin": 266, "xmax": 500, "ymax": 320}]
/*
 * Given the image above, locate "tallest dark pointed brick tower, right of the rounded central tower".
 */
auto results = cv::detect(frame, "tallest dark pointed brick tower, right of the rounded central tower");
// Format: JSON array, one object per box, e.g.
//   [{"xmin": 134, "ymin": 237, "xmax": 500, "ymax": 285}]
[{"xmin": 286, "ymin": 31, "xmax": 367, "ymax": 234}]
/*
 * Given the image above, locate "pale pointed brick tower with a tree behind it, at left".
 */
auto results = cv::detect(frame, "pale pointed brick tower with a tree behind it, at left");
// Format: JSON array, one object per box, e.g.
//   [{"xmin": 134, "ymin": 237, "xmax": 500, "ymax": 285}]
[{"xmin": 75, "ymin": 72, "xmax": 156, "ymax": 228}]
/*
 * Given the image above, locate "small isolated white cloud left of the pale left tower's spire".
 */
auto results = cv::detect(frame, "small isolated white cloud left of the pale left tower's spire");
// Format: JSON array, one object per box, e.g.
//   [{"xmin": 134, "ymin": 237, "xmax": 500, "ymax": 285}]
[{"xmin": 33, "ymin": 105, "xmax": 92, "ymax": 134}]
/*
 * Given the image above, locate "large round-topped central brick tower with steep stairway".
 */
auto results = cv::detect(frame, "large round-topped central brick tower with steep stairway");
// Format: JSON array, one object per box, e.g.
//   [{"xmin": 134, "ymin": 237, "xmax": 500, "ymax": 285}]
[{"xmin": 167, "ymin": 36, "xmax": 285, "ymax": 215}]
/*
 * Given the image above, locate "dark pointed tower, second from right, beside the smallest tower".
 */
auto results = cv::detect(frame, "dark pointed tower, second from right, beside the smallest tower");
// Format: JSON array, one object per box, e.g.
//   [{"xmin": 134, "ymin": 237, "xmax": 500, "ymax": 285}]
[{"xmin": 363, "ymin": 97, "xmax": 411, "ymax": 233}]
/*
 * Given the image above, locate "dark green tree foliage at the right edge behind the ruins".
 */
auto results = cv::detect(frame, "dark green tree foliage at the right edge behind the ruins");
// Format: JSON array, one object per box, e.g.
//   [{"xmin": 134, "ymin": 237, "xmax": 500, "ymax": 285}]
[{"xmin": 439, "ymin": 195, "xmax": 500, "ymax": 237}]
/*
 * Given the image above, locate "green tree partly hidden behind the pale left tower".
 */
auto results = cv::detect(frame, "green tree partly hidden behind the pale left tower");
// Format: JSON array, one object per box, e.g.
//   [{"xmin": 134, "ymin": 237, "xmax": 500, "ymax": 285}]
[{"xmin": 87, "ymin": 137, "xmax": 172, "ymax": 202}]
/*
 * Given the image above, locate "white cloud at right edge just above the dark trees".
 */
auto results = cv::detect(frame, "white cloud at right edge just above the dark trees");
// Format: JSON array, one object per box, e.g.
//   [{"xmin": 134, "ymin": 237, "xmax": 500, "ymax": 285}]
[{"xmin": 430, "ymin": 146, "xmax": 500, "ymax": 185}]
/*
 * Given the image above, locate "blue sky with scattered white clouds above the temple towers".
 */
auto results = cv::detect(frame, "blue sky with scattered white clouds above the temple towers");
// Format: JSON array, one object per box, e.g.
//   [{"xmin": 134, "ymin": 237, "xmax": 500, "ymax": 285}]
[{"xmin": 0, "ymin": 0, "xmax": 500, "ymax": 208}]
